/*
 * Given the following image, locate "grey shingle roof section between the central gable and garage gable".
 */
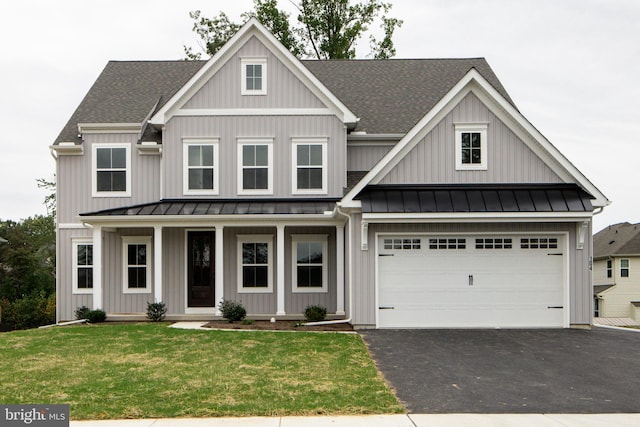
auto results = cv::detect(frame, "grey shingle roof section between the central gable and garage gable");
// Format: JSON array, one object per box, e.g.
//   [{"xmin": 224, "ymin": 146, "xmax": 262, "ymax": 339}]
[{"xmin": 302, "ymin": 58, "xmax": 515, "ymax": 134}]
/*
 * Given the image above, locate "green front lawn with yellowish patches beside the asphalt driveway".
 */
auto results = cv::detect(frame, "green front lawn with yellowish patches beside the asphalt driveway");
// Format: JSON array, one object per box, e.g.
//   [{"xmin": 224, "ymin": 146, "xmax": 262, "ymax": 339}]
[{"xmin": 0, "ymin": 324, "xmax": 404, "ymax": 419}]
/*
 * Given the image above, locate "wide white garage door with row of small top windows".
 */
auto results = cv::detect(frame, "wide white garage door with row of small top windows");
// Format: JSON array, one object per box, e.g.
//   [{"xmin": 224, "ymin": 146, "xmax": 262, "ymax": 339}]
[{"xmin": 378, "ymin": 235, "xmax": 566, "ymax": 328}]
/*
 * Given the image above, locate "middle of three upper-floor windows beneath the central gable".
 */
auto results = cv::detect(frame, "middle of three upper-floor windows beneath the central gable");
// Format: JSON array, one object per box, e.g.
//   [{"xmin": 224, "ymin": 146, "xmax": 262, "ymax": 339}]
[{"xmin": 238, "ymin": 140, "xmax": 273, "ymax": 194}]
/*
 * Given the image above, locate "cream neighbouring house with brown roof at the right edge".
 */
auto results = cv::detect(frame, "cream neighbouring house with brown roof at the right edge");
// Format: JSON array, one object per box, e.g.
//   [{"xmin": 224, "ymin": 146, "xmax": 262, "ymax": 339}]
[{"xmin": 593, "ymin": 222, "xmax": 640, "ymax": 322}]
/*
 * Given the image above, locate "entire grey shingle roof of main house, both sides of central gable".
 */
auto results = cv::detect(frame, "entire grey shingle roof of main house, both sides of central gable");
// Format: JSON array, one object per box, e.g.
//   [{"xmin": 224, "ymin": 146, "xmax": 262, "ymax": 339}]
[{"xmin": 55, "ymin": 58, "xmax": 513, "ymax": 143}]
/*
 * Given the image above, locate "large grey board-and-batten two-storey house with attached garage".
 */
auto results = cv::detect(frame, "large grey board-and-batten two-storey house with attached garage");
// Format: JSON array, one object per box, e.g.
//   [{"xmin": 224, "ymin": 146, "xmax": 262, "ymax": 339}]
[{"xmin": 52, "ymin": 19, "xmax": 609, "ymax": 328}]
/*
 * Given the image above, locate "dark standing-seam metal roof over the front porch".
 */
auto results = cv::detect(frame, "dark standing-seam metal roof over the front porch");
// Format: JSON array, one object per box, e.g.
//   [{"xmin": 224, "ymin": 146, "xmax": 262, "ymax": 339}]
[{"xmin": 80, "ymin": 199, "xmax": 339, "ymax": 217}]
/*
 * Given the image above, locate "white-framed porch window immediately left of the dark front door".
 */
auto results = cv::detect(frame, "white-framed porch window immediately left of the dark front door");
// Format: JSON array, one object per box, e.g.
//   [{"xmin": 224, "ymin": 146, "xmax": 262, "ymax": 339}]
[{"xmin": 122, "ymin": 236, "xmax": 151, "ymax": 294}]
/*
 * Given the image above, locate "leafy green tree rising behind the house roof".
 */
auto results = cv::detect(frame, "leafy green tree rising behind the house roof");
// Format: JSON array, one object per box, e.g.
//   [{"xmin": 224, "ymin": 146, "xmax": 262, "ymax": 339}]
[{"xmin": 184, "ymin": 0, "xmax": 402, "ymax": 59}]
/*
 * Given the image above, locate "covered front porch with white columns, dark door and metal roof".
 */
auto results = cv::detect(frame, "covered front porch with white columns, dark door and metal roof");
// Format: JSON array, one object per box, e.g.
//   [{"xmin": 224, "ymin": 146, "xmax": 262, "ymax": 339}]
[{"xmin": 80, "ymin": 200, "xmax": 346, "ymax": 320}]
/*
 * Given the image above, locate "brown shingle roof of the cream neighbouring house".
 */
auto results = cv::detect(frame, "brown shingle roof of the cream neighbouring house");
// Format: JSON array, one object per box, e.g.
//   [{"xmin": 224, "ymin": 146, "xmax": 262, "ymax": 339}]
[{"xmin": 593, "ymin": 222, "xmax": 640, "ymax": 258}]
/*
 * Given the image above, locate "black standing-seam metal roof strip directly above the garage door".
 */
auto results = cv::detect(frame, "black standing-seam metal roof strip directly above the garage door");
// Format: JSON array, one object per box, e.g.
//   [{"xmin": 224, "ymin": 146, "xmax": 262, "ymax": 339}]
[{"xmin": 356, "ymin": 184, "xmax": 593, "ymax": 213}]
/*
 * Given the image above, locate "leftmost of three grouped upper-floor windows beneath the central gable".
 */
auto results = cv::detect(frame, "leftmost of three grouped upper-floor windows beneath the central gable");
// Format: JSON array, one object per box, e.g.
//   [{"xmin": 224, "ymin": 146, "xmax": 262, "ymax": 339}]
[{"xmin": 183, "ymin": 139, "xmax": 219, "ymax": 195}]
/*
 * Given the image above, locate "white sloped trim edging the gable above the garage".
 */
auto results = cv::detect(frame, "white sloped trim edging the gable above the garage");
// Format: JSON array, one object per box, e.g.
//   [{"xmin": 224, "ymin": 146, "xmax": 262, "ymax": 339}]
[{"xmin": 341, "ymin": 68, "xmax": 611, "ymax": 211}]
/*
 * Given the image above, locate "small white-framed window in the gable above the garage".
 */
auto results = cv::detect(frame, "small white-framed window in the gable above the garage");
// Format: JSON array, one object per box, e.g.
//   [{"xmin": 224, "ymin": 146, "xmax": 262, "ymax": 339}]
[{"xmin": 455, "ymin": 123, "xmax": 487, "ymax": 170}]
